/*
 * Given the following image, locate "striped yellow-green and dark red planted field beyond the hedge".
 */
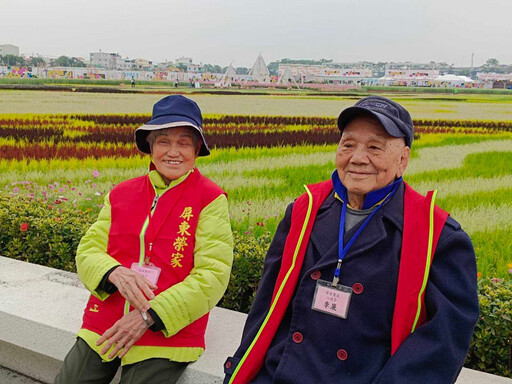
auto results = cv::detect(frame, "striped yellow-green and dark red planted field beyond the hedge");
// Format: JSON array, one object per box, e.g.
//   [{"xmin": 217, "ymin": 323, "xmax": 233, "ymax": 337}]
[{"xmin": 0, "ymin": 114, "xmax": 512, "ymax": 277}]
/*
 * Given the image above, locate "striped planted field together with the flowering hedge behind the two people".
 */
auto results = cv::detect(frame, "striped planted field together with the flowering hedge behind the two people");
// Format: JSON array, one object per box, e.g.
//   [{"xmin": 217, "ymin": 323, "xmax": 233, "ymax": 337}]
[{"xmin": 0, "ymin": 106, "xmax": 512, "ymax": 377}]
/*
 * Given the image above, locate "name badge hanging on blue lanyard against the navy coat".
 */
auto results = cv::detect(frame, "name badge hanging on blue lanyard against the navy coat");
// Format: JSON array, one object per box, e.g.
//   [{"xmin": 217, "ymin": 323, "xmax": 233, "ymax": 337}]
[{"xmin": 311, "ymin": 280, "xmax": 352, "ymax": 319}]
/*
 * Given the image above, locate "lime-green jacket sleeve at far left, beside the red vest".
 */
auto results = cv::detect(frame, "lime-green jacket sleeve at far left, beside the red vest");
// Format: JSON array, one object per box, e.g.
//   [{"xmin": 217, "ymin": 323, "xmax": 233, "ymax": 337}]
[{"xmin": 76, "ymin": 194, "xmax": 120, "ymax": 300}]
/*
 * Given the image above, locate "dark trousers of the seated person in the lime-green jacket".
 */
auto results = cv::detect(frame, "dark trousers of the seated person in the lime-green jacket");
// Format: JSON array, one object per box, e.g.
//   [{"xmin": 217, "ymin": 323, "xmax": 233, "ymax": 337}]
[{"xmin": 54, "ymin": 338, "xmax": 188, "ymax": 384}]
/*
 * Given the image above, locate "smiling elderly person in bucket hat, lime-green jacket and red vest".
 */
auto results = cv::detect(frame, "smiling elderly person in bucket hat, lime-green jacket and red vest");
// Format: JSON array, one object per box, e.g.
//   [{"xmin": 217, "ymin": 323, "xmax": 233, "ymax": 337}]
[{"xmin": 55, "ymin": 96, "xmax": 233, "ymax": 384}]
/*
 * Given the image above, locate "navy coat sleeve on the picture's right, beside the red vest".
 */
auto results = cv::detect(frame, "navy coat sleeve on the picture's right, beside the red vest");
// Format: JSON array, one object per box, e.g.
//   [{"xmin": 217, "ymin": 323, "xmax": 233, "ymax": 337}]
[{"xmin": 373, "ymin": 218, "xmax": 479, "ymax": 384}]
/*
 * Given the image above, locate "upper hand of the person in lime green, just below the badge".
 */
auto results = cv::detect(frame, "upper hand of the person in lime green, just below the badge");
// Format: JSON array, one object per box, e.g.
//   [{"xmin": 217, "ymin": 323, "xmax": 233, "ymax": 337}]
[{"xmin": 108, "ymin": 266, "xmax": 158, "ymax": 317}]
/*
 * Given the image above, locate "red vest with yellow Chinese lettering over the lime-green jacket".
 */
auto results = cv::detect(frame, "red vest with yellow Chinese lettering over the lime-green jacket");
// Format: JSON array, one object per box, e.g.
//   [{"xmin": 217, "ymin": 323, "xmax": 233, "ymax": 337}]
[{"xmin": 82, "ymin": 169, "xmax": 224, "ymax": 348}]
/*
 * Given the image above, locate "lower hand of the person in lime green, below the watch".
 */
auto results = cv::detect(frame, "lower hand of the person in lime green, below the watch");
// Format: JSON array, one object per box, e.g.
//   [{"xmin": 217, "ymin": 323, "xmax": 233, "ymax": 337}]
[{"xmin": 96, "ymin": 310, "xmax": 153, "ymax": 359}]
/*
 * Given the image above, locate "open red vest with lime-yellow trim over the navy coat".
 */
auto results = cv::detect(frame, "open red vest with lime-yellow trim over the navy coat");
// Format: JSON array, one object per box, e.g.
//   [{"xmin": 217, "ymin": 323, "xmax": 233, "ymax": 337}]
[{"xmin": 229, "ymin": 180, "xmax": 448, "ymax": 384}]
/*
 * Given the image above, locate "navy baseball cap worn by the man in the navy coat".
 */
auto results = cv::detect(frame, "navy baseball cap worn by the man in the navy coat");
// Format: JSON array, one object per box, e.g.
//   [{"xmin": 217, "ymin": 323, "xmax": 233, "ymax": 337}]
[{"xmin": 338, "ymin": 96, "xmax": 414, "ymax": 147}]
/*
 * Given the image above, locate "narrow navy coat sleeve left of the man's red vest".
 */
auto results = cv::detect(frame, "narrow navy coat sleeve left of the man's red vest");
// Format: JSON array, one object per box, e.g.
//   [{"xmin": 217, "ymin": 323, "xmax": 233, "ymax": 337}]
[{"xmin": 224, "ymin": 203, "xmax": 293, "ymax": 383}]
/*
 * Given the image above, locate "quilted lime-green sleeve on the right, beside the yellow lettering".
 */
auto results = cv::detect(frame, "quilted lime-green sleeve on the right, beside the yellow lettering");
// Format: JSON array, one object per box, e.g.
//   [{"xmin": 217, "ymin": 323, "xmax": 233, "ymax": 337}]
[{"xmin": 150, "ymin": 195, "xmax": 233, "ymax": 337}]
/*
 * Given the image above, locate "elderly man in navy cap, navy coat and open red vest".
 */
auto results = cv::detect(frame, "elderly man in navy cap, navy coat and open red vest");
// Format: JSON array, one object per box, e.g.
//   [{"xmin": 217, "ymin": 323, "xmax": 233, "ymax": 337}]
[{"xmin": 224, "ymin": 96, "xmax": 478, "ymax": 384}]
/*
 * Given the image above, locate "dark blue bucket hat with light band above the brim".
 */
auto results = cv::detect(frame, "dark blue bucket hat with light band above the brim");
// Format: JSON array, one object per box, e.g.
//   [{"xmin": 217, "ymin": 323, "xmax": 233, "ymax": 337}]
[{"xmin": 135, "ymin": 95, "xmax": 210, "ymax": 156}]
